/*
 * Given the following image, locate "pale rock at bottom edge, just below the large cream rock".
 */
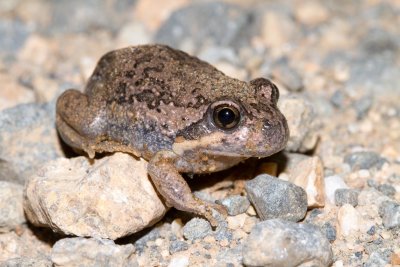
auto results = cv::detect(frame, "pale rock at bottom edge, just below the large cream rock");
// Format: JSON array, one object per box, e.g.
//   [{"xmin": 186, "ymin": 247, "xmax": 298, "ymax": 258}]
[{"xmin": 51, "ymin": 237, "xmax": 138, "ymax": 267}]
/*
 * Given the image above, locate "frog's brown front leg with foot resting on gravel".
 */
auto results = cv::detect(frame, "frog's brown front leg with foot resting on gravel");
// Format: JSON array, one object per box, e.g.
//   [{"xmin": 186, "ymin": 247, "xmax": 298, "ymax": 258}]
[{"xmin": 148, "ymin": 151, "xmax": 227, "ymax": 226}]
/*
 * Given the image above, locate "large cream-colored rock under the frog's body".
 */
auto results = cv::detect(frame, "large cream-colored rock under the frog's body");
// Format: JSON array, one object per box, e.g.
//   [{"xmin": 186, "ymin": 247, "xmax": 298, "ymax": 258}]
[{"xmin": 24, "ymin": 153, "xmax": 166, "ymax": 239}]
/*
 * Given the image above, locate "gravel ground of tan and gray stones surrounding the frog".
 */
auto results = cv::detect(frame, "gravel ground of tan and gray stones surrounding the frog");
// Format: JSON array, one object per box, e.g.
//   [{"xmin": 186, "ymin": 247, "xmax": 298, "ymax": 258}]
[{"xmin": 0, "ymin": 0, "xmax": 400, "ymax": 267}]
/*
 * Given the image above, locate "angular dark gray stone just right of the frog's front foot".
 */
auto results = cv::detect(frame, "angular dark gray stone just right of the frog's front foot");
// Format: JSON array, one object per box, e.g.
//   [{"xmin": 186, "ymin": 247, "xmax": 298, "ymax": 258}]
[{"xmin": 245, "ymin": 174, "xmax": 307, "ymax": 222}]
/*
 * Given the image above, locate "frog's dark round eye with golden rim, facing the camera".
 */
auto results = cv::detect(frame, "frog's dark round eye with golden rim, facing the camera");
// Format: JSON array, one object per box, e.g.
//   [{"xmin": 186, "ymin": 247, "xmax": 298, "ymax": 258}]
[{"xmin": 213, "ymin": 103, "xmax": 240, "ymax": 130}]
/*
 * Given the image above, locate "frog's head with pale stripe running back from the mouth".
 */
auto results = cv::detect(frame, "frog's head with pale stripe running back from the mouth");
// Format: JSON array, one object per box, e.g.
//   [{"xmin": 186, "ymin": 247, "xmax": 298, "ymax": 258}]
[{"xmin": 173, "ymin": 78, "xmax": 289, "ymax": 162}]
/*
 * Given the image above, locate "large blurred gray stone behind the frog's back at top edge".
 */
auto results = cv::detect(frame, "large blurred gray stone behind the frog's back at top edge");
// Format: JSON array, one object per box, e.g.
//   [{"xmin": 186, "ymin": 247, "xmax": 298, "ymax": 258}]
[{"xmin": 155, "ymin": 2, "xmax": 251, "ymax": 48}]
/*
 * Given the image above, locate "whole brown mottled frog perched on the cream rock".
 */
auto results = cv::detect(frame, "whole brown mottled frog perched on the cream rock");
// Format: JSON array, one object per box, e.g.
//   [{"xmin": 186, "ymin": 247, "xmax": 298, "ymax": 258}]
[{"xmin": 56, "ymin": 44, "xmax": 289, "ymax": 226}]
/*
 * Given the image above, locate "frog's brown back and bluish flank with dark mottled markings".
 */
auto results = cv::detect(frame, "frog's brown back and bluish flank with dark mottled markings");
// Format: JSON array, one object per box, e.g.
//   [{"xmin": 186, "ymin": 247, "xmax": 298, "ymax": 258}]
[{"xmin": 85, "ymin": 45, "xmax": 243, "ymax": 157}]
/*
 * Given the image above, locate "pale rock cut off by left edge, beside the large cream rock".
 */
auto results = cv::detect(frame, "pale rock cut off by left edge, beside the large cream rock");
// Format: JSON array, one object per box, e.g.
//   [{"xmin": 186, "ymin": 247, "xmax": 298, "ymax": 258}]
[{"xmin": 0, "ymin": 181, "xmax": 25, "ymax": 233}]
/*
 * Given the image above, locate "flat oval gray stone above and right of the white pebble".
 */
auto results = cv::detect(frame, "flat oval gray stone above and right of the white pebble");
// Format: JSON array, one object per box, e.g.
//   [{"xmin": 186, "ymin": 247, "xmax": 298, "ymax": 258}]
[{"xmin": 344, "ymin": 151, "xmax": 386, "ymax": 170}]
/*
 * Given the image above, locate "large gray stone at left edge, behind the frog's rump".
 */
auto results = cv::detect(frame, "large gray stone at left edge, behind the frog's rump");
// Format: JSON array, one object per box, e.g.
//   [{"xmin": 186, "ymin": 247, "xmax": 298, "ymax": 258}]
[{"xmin": 0, "ymin": 102, "xmax": 63, "ymax": 184}]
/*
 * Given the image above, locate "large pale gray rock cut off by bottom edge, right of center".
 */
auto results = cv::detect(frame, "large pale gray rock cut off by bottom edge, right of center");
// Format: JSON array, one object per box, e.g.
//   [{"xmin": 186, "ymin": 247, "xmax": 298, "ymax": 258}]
[{"xmin": 243, "ymin": 219, "xmax": 332, "ymax": 266}]
